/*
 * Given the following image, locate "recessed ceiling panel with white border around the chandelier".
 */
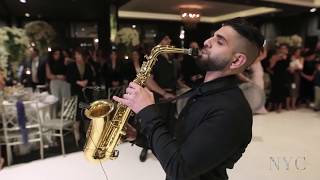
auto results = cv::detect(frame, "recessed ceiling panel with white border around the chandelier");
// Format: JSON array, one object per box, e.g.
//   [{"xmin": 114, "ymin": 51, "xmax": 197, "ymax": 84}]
[{"xmin": 119, "ymin": 0, "xmax": 320, "ymax": 23}]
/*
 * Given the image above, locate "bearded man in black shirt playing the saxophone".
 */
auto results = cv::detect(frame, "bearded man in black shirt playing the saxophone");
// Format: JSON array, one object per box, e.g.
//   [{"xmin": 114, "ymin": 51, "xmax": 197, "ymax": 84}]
[{"xmin": 113, "ymin": 18, "xmax": 264, "ymax": 180}]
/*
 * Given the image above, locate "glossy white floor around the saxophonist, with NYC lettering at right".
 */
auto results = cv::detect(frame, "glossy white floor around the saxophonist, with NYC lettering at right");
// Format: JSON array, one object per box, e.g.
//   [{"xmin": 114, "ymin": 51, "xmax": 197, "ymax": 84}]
[{"xmin": 0, "ymin": 109, "xmax": 320, "ymax": 180}]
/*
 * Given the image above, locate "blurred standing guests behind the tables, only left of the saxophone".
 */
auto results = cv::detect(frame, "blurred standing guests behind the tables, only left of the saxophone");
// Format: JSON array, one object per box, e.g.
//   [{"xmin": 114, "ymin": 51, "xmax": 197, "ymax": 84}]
[{"xmin": 14, "ymin": 48, "xmax": 146, "ymax": 146}]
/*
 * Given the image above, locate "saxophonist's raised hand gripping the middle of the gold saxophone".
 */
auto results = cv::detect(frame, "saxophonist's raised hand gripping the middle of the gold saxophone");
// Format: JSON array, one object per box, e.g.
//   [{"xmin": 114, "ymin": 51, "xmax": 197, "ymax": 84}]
[{"xmin": 113, "ymin": 82, "xmax": 155, "ymax": 113}]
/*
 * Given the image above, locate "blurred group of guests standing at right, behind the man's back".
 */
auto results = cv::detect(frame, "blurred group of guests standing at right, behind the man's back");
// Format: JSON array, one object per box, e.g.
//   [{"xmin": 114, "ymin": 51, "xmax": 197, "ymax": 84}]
[{"xmin": 261, "ymin": 44, "xmax": 320, "ymax": 112}]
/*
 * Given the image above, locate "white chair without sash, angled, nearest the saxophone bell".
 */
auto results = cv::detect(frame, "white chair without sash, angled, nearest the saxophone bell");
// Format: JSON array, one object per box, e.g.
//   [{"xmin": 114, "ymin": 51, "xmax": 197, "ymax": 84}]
[{"xmin": 42, "ymin": 96, "xmax": 78, "ymax": 155}]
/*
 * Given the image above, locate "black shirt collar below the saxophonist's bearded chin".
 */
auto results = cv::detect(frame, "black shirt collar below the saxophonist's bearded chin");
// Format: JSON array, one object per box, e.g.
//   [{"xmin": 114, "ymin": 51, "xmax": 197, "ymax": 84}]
[{"xmin": 194, "ymin": 75, "xmax": 238, "ymax": 96}]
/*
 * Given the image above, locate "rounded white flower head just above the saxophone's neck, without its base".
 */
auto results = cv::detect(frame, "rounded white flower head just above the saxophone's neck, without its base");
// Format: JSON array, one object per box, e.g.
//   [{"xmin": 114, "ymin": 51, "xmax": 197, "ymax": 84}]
[{"xmin": 115, "ymin": 27, "xmax": 140, "ymax": 47}]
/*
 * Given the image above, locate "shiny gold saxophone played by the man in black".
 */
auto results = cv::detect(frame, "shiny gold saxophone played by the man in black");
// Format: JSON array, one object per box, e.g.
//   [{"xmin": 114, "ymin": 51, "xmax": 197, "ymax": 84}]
[{"xmin": 84, "ymin": 45, "xmax": 198, "ymax": 162}]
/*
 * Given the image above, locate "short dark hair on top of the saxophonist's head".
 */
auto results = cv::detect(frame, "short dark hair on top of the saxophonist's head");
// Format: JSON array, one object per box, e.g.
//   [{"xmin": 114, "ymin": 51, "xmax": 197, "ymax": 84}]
[{"xmin": 222, "ymin": 17, "xmax": 264, "ymax": 51}]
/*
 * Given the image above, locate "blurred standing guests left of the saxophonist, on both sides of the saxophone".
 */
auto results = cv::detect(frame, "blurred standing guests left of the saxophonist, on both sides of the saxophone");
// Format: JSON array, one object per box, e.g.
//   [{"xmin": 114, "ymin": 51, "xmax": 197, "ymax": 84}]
[{"xmin": 7, "ymin": 33, "xmax": 204, "ymax": 161}]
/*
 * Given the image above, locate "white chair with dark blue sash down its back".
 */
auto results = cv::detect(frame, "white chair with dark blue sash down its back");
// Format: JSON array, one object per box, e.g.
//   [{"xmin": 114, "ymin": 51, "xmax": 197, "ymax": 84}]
[{"xmin": 0, "ymin": 101, "xmax": 44, "ymax": 165}]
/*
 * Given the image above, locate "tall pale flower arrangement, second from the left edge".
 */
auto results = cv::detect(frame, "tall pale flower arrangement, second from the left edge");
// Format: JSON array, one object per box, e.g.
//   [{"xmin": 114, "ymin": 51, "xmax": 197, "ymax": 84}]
[{"xmin": 24, "ymin": 21, "xmax": 56, "ymax": 54}]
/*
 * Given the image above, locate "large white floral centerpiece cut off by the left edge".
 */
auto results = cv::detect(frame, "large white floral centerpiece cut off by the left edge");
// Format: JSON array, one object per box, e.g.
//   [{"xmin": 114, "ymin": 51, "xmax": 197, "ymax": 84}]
[{"xmin": 0, "ymin": 27, "xmax": 29, "ymax": 77}]
